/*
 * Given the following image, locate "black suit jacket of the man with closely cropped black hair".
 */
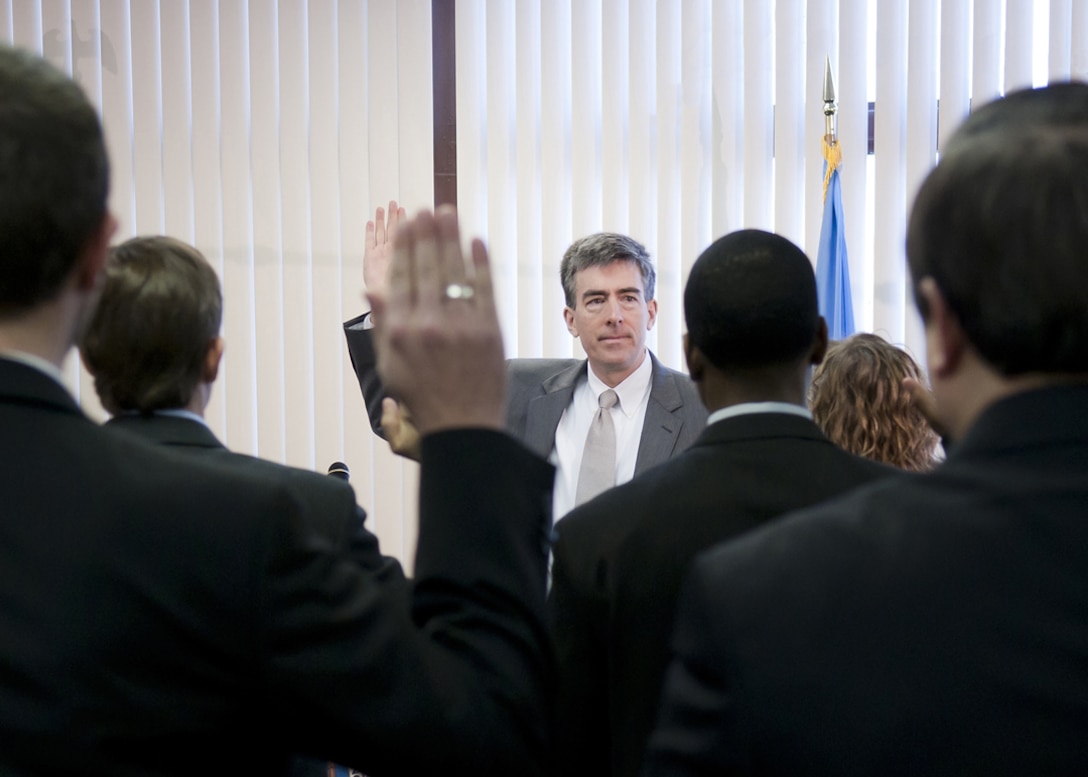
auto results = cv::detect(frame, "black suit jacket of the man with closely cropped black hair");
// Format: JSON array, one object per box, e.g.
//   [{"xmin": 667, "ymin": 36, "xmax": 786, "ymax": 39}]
[{"xmin": 549, "ymin": 412, "xmax": 895, "ymax": 777}]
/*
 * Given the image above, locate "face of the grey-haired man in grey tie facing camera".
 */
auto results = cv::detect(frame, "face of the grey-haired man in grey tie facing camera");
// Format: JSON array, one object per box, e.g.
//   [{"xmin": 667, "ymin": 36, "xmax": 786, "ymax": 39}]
[{"xmin": 562, "ymin": 259, "xmax": 657, "ymax": 385}]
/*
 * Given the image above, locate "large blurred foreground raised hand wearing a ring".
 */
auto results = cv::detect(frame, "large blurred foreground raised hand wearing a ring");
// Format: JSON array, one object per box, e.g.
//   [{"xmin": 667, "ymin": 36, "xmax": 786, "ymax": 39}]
[{"xmin": 368, "ymin": 206, "xmax": 506, "ymax": 436}]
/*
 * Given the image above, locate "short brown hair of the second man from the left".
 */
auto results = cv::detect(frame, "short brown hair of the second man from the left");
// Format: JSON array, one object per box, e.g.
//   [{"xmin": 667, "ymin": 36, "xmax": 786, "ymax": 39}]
[{"xmin": 81, "ymin": 237, "xmax": 223, "ymax": 415}]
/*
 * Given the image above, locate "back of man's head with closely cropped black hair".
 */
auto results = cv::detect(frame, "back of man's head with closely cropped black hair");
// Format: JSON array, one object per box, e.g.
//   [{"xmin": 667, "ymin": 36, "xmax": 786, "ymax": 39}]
[{"xmin": 683, "ymin": 230, "xmax": 827, "ymax": 406}]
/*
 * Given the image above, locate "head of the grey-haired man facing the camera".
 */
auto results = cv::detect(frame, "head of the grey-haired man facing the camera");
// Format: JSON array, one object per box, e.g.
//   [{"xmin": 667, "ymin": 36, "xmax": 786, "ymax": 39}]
[{"xmin": 559, "ymin": 232, "xmax": 657, "ymax": 385}]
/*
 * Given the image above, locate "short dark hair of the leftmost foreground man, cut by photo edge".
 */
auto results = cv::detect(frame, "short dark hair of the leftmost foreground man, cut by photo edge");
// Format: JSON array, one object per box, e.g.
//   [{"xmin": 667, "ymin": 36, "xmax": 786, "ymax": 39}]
[{"xmin": 0, "ymin": 45, "xmax": 110, "ymax": 317}]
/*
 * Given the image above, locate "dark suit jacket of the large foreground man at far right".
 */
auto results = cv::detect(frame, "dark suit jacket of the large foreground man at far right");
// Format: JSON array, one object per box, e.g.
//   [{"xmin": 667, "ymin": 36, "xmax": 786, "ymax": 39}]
[{"xmin": 645, "ymin": 387, "xmax": 1088, "ymax": 777}]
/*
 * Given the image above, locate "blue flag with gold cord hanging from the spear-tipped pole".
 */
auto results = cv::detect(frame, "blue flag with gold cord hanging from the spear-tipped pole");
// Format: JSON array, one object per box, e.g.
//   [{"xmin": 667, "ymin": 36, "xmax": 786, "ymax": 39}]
[{"xmin": 816, "ymin": 137, "xmax": 854, "ymax": 340}]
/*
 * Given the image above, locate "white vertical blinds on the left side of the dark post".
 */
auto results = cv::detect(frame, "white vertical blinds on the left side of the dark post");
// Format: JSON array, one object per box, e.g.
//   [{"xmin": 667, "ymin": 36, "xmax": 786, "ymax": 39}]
[{"xmin": 0, "ymin": 0, "xmax": 433, "ymax": 563}]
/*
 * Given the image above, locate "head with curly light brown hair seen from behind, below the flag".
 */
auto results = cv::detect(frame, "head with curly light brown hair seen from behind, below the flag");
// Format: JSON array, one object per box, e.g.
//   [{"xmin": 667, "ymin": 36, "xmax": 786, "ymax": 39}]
[{"xmin": 808, "ymin": 332, "xmax": 940, "ymax": 471}]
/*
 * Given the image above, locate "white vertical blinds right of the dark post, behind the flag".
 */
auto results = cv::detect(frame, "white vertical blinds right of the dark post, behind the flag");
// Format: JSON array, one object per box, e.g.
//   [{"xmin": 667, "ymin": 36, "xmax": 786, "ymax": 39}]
[{"xmin": 457, "ymin": 0, "xmax": 1088, "ymax": 369}]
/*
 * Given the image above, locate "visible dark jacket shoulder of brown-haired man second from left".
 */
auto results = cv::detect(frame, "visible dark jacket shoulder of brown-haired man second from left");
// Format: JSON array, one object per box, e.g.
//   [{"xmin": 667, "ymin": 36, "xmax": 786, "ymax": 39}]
[{"xmin": 106, "ymin": 415, "xmax": 404, "ymax": 580}]
